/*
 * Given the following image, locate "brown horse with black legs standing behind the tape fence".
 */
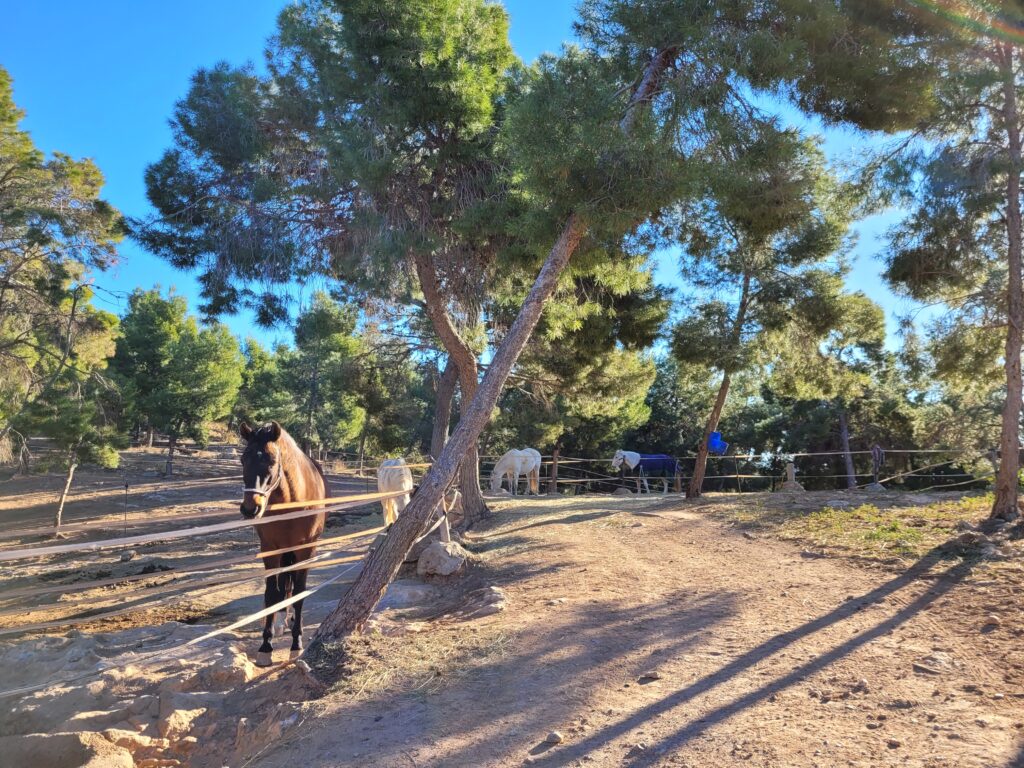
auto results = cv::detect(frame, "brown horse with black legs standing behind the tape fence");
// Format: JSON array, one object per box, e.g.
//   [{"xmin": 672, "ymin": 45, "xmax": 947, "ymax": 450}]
[{"xmin": 239, "ymin": 421, "xmax": 328, "ymax": 667}]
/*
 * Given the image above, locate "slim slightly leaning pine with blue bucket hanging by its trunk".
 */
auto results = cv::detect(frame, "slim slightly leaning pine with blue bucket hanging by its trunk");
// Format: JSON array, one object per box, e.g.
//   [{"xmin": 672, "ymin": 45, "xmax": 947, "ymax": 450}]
[{"xmin": 673, "ymin": 117, "xmax": 851, "ymax": 498}]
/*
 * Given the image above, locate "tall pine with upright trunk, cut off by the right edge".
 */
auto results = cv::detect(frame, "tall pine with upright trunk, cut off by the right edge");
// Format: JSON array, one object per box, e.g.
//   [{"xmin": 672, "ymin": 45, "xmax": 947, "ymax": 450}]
[{"xmin": 873, "ymin": 1, "xmax": 1024, "ymax": 519}]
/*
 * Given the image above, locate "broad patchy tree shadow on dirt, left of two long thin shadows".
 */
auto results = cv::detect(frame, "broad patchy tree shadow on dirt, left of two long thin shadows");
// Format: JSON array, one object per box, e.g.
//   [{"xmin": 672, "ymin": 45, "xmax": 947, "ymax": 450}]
[{"xmin": 253, "ymin": 591, "xmax": 735, "ymax": 766}]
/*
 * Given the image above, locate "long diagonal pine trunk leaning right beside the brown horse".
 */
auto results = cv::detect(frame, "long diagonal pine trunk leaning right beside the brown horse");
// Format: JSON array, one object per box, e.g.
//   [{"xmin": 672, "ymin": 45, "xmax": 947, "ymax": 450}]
[{"xmin": 309, "ymin": 48, "xmax": 676, "ymax": 654}]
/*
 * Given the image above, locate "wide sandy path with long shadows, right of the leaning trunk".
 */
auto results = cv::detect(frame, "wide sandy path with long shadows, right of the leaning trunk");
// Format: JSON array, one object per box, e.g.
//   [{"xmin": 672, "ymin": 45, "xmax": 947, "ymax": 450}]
[{"xmin": 252, "ymin": 497, "xmax": 1024, "ymax": 768}]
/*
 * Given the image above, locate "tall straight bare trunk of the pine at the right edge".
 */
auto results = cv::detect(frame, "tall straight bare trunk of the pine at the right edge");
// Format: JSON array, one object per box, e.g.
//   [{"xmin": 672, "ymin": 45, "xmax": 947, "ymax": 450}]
[{"xmin": 991, "ymin": 45, "xmax": 1024, "ymax": 520}]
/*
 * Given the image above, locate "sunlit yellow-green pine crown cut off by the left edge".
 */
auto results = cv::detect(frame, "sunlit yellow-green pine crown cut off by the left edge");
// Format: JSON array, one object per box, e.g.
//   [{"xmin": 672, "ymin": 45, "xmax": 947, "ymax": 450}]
[{"xmin": 0, "ymin": 68, "xmax": 124, "ymax": 440}]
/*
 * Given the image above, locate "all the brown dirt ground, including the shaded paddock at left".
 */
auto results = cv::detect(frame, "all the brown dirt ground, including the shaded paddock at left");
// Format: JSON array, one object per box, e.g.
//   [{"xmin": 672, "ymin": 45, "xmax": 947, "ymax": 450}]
[{"xmin": 0, "ymin": 460, "xmax": 1024, "ymax": 768}]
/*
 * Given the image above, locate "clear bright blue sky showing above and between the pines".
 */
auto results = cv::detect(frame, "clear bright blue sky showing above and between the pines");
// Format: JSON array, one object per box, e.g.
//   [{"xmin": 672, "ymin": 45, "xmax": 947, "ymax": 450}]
[{"xmin": 0, "ymin": 0, "xmax": 925, "ymax": 342}]
